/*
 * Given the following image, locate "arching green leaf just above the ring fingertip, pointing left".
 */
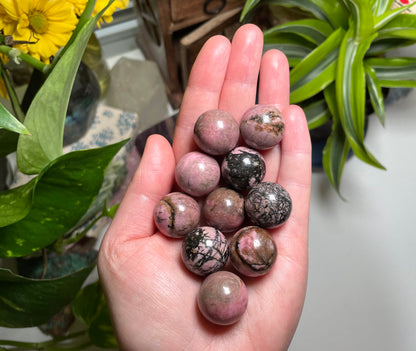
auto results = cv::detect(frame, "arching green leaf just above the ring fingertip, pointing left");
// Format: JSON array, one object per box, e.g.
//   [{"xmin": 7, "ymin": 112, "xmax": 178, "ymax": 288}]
[{"xmin": 263, "ymin": 19, "xmax": 333, "ymax": 45}]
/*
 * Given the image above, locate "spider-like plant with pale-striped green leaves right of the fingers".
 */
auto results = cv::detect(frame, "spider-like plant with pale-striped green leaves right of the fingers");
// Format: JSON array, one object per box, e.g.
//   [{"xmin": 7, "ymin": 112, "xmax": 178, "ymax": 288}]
[{"xmin": 241, "ymin": 0, "xmax": 416, "ymax": 193}]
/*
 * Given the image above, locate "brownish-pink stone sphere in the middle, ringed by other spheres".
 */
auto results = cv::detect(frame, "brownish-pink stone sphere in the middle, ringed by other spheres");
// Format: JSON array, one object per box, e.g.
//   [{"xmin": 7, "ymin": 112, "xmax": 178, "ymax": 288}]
[{"xmin": 202, "ymin": 187, "xmax": 244, "ymax": 233}]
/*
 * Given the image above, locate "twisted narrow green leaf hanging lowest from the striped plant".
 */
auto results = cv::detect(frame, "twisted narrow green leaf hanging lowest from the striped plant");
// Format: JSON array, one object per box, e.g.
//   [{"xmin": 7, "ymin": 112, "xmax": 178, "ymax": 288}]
[{"xmin": 322, "ymin": 84, "xmax": 350, "ymax": 198}]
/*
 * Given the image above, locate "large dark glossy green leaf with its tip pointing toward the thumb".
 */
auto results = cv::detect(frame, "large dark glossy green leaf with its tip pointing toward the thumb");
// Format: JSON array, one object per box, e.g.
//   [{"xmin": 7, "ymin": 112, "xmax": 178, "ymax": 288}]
[{"xmin": 0, "ymin": 141, "xmax": 126, "ymax": 257}]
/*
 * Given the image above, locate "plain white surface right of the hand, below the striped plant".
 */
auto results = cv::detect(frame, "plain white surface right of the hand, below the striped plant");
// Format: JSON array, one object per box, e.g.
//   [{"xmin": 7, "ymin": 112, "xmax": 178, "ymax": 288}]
[{"xmin": 290, "ymin": 47, "xmax": 416, "ymax": 351}]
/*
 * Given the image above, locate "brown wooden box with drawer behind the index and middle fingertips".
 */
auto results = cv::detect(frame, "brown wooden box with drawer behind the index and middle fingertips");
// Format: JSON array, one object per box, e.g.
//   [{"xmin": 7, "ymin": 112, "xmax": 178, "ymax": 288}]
[{"xmin": 134, "ymin": 0, "xmax": 245, "ymax": 108}]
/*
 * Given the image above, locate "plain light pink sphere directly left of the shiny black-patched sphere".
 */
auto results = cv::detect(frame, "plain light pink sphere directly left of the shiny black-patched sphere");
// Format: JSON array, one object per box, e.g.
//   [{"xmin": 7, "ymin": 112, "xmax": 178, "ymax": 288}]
[{"xmin": 175, "ymin": 151, "xmax": 221, "ymax": 197}]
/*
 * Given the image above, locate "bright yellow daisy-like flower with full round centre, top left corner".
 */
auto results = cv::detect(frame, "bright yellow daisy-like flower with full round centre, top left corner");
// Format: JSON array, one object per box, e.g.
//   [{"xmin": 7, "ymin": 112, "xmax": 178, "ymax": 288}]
[{"xmin": 0, "ymin": 0, "xmax": 78, "ymax": 63}]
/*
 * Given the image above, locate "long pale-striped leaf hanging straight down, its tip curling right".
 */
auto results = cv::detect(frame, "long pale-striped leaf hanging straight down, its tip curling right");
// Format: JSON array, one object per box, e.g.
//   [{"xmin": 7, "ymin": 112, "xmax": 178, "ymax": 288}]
[{"xmin": 335, "ymin": 27, "xmax": 384, "ymax": 169}]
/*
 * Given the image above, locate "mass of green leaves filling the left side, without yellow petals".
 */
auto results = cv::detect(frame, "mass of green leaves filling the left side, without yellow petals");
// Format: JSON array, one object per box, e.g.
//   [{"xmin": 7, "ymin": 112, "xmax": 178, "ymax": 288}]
[{"xmin": 0, "ymin": 0, "xmax": 123, "ymax": 350}]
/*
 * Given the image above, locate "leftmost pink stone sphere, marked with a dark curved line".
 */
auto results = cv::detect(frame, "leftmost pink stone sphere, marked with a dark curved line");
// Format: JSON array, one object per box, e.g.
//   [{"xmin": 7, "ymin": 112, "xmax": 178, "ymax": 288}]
[{"xmin": 154, "ymin": 192, "xmax": 201, "ymax": 238}]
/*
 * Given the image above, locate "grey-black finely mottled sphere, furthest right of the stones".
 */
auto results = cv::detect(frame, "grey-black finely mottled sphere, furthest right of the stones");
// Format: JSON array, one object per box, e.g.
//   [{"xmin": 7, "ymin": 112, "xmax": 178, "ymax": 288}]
[{"xmin": 244, "ymin": 182, "xmax": 292, "ymax": 228}]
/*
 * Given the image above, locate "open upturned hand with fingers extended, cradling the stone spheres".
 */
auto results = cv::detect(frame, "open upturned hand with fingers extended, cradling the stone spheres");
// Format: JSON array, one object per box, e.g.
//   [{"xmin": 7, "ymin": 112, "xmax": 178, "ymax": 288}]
[{"xmin": 98, "ymin": 24, "xmax": 311, "ymax": 351}]
